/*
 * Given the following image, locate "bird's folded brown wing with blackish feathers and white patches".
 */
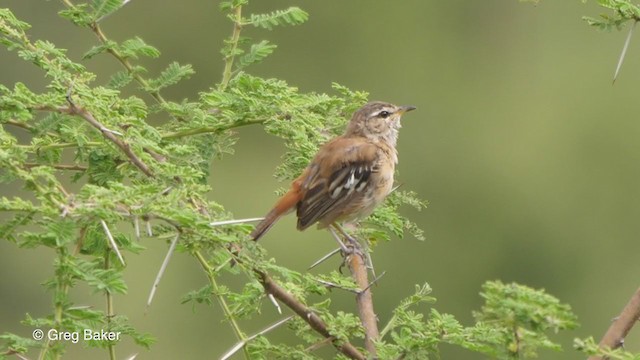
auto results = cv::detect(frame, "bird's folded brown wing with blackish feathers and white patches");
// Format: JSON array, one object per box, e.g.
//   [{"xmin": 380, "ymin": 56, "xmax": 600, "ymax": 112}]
[{"xmin": 297, "ymin": 137, "xmax": 377, "ymax": 230}]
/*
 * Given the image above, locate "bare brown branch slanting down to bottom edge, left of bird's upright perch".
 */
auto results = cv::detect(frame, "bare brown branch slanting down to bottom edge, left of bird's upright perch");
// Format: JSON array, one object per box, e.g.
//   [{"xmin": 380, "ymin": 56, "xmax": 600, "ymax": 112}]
[{"xmin": 254, "ymin": 269, "xmax": 366, "ymax": 360}]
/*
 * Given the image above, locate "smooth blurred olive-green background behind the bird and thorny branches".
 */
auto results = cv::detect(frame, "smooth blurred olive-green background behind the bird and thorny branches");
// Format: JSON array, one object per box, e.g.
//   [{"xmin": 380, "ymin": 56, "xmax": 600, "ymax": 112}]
[{"xmin": 0, "ymin": 0, "xmax": 640, "ymax": 359}]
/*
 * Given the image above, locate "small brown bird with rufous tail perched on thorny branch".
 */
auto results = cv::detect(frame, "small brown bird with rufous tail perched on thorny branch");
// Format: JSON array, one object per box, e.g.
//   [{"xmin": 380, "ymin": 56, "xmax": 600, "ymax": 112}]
[{"xmin": 251, "ymin": 101, "xmax": 415, "ymax": 241}]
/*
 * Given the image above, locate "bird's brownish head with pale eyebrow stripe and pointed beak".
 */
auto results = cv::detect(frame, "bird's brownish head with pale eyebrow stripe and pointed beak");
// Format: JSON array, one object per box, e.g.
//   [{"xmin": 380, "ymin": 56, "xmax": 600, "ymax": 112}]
[{"xmin": 346, "ymin": 101, "xmax": 415, "ymax": 146}]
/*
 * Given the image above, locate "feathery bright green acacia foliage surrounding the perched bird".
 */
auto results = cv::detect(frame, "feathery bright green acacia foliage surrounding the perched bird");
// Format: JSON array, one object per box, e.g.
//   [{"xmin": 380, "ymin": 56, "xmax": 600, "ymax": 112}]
[{"xmin": 0, "ymin": 0, "xmax": 640, "ymax": 359}]
